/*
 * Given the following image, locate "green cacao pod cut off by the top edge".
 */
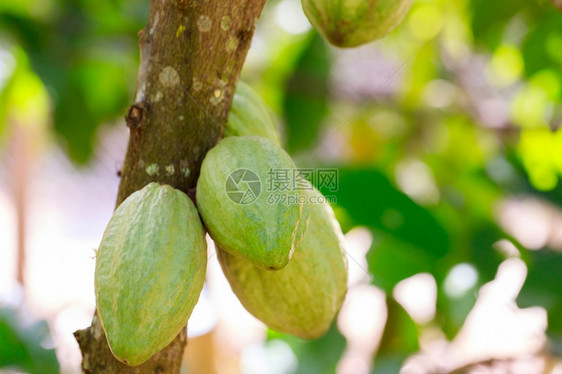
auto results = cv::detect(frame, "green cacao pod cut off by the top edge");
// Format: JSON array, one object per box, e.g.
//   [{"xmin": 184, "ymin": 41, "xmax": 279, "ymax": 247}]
[{"xmin": 302, "ymin": 0, "xmax": 413, "ymax": 48}]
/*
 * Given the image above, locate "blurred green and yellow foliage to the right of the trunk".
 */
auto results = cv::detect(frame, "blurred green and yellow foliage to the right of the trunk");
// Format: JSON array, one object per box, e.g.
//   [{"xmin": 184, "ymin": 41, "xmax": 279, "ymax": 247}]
[{"xmin": 249, "ymin": 0, "xmax": 562, "ymax": 373}]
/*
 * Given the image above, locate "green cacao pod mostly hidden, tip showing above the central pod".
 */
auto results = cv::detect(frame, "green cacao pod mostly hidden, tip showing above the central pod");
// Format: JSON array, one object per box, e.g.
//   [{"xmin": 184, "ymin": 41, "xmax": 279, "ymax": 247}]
[{"xmin": 224, "ymin": 81, "xmax": 281, "ymax": 147}]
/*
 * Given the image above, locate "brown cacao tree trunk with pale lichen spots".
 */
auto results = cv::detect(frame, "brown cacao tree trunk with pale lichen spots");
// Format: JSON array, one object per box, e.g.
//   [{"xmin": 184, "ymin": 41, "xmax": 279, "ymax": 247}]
[{"xmin": 74, "ymin": 0, "xmax": 265, "ymax": 373}]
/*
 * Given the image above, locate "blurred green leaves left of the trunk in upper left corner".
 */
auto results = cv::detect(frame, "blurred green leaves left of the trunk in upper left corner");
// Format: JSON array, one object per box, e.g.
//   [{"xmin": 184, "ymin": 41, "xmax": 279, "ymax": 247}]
[{"xmin": 0, "ymin": 0, "xmax": 144, "ymax": 163}]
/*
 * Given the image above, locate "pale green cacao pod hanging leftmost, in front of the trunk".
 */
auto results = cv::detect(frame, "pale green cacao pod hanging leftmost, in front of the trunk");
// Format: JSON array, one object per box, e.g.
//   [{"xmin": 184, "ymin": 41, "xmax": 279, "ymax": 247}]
[{"xmin": 95, "ymin": 183, "xmax": 207, "ymax": 366}]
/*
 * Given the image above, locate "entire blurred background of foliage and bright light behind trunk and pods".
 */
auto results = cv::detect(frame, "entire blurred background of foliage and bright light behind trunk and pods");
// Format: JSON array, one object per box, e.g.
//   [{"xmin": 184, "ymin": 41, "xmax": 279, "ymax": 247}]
[{"xmin": 0, "ymin": 0, "xmax": 562, "ymax": 374}]
